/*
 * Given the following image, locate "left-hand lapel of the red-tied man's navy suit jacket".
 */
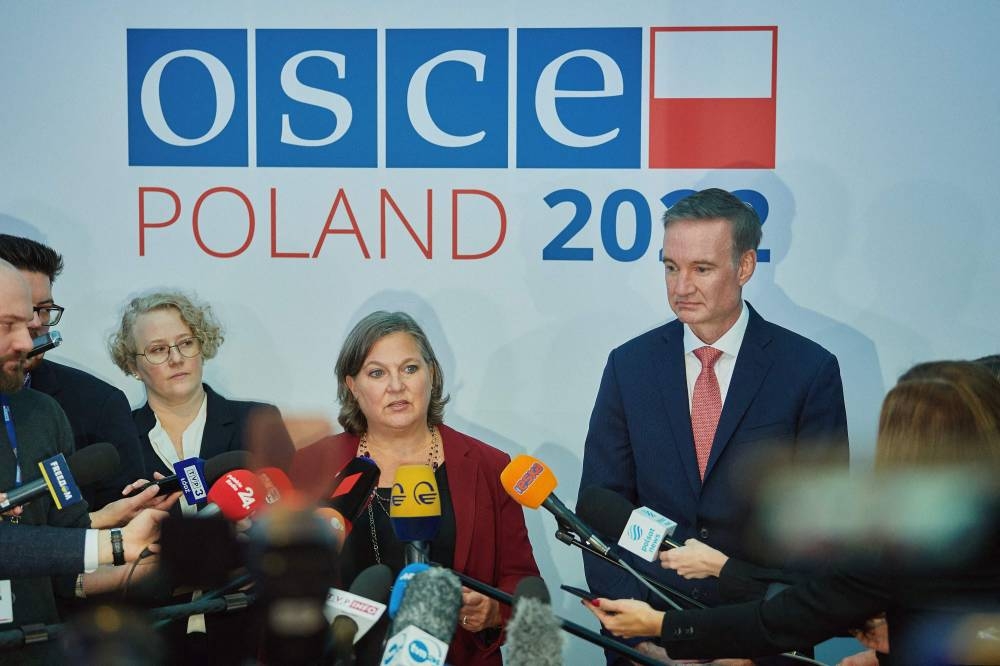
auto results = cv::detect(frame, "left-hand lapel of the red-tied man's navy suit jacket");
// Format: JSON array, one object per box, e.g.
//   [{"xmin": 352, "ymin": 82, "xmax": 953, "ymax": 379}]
[{"xmin": 654, "ymin": 319, "xmax": 701, "ymax": 497}]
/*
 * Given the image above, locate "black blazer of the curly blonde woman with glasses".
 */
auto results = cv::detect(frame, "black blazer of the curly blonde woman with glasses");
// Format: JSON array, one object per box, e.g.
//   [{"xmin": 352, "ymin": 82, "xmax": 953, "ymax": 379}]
[{"xmin": 132, "ymin": 384, "xmax": 295, "ymax": 479}]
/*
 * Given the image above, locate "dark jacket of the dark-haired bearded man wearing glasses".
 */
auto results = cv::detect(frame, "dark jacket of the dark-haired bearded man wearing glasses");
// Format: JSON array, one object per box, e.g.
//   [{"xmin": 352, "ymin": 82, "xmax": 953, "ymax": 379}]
[{"xmin": 31, "ymin": 360, "xmax": 145, "ymax": 511}]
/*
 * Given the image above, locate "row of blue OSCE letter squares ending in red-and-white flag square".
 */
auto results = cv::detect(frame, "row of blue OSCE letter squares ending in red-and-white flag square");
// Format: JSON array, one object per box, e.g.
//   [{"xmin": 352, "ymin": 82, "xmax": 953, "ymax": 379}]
[{"xmin": 127, "ymin": 26, "xmax": 776, "ymax": 169}]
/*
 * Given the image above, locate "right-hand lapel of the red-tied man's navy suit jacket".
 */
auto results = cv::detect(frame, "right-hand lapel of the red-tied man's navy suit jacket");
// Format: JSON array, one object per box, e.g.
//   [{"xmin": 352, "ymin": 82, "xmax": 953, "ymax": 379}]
[{"xmin": 705, "ymin": 303, "xmax": 773, "ymax": 478}]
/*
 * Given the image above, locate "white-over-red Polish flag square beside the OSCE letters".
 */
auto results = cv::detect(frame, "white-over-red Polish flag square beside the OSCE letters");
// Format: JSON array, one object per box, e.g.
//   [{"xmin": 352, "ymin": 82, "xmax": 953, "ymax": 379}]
[{"xmin": 649, "ymin": 26, "xmax": 778, "ymax": 169}]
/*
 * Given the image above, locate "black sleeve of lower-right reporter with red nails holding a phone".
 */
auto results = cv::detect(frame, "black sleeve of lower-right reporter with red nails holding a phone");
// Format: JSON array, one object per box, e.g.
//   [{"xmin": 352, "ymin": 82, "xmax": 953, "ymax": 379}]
[{"xmin": 661, "ymin": 545, "xmax": 1000, "ymax": 664}]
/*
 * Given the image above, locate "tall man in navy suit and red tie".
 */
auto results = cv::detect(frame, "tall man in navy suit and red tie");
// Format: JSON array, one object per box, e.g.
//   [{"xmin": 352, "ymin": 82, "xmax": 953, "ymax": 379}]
[{"xmin": 580, "ymin": 189, "xmax": 847, "ymax": 660}]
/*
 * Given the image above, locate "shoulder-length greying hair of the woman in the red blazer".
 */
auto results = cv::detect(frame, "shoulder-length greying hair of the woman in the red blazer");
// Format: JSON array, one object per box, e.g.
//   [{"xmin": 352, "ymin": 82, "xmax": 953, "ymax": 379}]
[{"xmin": 336, "ymin": 310, "xmax": 449, "ymax": 435}]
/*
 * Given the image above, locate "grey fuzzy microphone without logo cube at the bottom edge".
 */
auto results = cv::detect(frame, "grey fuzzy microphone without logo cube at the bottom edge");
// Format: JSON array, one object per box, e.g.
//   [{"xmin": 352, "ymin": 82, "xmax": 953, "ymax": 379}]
[{"xmin": 504, "ymin": 576, "xmax": 563, "ymax": 666}]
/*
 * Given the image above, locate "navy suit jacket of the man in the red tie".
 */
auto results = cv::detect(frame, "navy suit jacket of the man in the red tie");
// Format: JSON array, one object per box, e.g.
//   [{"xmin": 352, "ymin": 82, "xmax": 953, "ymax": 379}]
[{"xmin": 580, "ymin": 304, "xmax": 847, "ymax": 607}]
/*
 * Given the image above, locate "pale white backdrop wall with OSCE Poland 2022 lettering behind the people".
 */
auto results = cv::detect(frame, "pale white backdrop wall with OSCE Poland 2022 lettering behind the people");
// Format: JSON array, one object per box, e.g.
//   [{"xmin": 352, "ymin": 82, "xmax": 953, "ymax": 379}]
[{"xmin": 0, "ymin": 0, "xmax": 1000, "ymax": 663}]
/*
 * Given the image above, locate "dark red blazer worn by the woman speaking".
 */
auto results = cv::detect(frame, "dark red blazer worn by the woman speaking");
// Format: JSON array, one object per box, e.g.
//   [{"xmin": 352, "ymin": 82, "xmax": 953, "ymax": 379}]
[{"xmin": 291, "ymin": 425, "xmax": 538, "ymax": 666}]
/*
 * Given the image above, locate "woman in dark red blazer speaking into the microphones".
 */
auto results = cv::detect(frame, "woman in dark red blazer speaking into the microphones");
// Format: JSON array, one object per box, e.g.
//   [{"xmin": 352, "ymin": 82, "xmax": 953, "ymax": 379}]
[{"xmin": 291, "ymin": 311, "xmax": 538, "ymax": 665}]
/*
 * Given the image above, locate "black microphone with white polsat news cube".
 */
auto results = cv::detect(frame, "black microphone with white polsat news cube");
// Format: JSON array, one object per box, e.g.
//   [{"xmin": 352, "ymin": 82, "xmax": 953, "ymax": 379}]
[{"xmin": 576, "ymin": 486, "xmax": 683, "ymax": 562}]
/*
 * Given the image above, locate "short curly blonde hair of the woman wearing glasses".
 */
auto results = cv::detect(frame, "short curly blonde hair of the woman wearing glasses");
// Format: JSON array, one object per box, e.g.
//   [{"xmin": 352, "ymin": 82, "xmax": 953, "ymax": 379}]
[{"xmin": 108, "ymin": 291, "xmax": 225, "ymax": 375}]
